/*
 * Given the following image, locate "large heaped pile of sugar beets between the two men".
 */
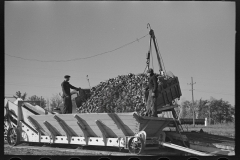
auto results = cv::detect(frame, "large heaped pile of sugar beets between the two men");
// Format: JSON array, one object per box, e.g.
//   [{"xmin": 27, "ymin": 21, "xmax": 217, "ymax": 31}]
[{"xmin": 77, "ymin": 73, "xmax": 175, "ymax": 115}]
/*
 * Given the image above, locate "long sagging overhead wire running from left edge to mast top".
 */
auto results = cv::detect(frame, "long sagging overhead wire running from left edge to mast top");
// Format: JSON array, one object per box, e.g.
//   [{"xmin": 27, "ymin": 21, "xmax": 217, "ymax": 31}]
[{"xmin": 6, "ymin": 34, "xmax": 148, "ymax": 62}]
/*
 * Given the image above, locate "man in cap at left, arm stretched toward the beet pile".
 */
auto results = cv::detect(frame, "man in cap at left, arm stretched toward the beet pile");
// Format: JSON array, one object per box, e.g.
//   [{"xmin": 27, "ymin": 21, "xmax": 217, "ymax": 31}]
[{"xmin": 61, "ymin": 75, "xmax": 80, "ymax": 114}]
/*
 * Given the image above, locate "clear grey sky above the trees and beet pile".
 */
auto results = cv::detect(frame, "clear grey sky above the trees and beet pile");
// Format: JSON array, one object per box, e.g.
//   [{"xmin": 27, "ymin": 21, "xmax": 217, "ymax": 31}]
[{"xmin": 4, "ymin": 1, "xmax": 236, "ymax": 105}]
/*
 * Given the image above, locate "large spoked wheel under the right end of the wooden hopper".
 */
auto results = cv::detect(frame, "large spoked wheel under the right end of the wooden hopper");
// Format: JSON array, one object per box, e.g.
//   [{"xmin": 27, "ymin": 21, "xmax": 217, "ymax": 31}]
[{"xmin": 128, "ymin": 137, "xmax": 145, "ymax": 154}]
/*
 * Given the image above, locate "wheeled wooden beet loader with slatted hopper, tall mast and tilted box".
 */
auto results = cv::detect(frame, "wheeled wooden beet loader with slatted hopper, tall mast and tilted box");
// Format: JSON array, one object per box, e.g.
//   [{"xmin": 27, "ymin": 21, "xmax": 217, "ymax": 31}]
[{"xmin": 4, "ymin": 24, "xmax": 216, "ymax": 156}]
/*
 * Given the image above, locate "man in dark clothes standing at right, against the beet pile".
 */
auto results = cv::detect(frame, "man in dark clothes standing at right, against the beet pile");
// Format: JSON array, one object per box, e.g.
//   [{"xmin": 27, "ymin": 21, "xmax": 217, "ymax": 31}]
[{"xmin": 145, "ymin": 68, "xmax": 158, "ymax": 117}]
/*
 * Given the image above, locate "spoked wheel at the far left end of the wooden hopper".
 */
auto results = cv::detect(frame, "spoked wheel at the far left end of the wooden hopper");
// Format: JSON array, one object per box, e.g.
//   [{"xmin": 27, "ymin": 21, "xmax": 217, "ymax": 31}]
[{"xmin": 7, "ymin": 128, "xmax": 20, "ymax": 146}]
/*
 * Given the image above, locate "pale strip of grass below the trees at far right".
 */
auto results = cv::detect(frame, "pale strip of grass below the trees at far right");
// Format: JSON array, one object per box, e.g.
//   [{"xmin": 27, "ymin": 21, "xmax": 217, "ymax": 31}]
[{"xmin": 182, "ymin": 123, "xmax": 235, "ymax": 138}]
